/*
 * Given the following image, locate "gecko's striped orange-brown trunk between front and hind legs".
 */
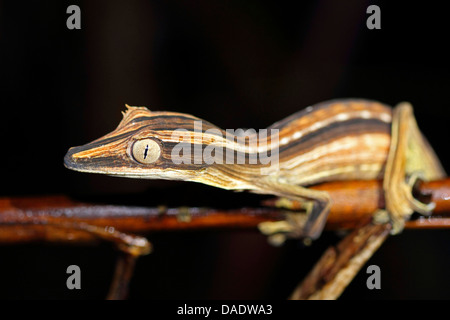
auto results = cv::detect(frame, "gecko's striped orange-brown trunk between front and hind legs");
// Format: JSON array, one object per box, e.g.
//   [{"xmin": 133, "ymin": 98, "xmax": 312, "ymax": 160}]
[{"xmin": 270, "ymin": 100, "xmax": 392, "ymax": 185}]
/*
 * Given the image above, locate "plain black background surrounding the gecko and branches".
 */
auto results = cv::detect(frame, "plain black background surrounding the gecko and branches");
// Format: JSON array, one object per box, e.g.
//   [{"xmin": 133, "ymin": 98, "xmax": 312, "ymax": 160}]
[{"xmin": 0, "ymin": 0, "xmax": 450, "ymax": 299}]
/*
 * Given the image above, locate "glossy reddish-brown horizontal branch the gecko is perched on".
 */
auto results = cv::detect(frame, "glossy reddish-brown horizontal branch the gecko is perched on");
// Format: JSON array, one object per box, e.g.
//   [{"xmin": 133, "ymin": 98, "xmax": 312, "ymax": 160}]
[{"xmin": 0, "ymin": 179, "xmax": 450, "ymax": 243}]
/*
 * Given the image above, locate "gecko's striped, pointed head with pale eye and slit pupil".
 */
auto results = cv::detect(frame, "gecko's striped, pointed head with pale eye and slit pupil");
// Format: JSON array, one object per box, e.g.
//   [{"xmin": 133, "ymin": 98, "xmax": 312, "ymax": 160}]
[{"xmin": 64, "ymin": 106, "xmax": 218, "ymax": 180}]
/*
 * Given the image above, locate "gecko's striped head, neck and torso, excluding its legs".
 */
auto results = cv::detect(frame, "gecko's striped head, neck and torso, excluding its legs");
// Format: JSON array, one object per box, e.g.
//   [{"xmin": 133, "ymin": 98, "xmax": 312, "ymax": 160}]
[{"xmin": 65, "ymin": 100, "xmax": 392, "ymax": 189}]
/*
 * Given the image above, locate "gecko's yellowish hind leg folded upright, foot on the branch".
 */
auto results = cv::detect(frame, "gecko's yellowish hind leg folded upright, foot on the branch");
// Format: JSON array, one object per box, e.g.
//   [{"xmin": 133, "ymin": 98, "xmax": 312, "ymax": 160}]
[{"xmin": 383, "ymin": 102, "xmax": 446, "ymax": 234}]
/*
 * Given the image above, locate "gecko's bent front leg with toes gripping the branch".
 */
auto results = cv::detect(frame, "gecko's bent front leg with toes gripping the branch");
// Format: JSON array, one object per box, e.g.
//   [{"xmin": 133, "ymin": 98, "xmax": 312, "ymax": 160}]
[{"xmin": 258, "ymin": 179, "xmax": 331, "ymax": 244}]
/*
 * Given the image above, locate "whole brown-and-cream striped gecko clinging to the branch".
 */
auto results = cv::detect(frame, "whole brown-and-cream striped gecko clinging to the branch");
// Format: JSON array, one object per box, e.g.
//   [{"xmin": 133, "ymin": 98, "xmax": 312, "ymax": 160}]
[{"xmin": 64, "ymin": 99, "xmax": 446, "ymax": 246}]
